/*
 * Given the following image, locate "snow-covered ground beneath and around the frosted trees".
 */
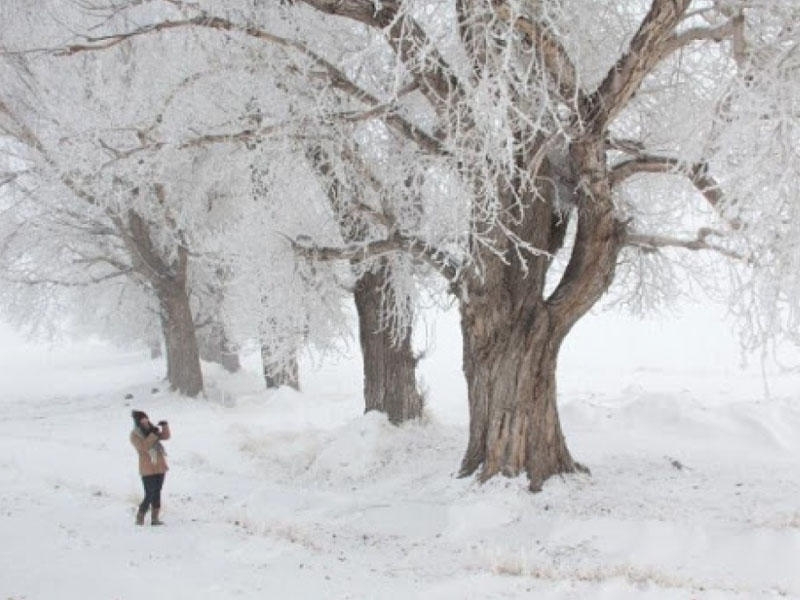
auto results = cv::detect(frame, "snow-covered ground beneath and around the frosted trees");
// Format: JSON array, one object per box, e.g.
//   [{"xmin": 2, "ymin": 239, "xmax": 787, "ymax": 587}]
[{"xmin": 0, "ymin": 315, "xmax": 800, "ymax": 600}]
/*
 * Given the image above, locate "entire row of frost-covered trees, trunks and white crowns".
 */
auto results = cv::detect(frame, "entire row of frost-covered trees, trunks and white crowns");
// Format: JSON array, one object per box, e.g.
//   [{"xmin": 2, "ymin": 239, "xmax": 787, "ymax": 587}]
[{"xmin": 0, "ymin": 0, "xmax": 800, "ymax": 489}]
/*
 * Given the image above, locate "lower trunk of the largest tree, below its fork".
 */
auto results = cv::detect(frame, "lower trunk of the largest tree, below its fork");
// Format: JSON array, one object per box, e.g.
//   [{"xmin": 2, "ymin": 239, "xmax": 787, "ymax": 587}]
[{"xmin": 461, "ymin": 302, "xmax": 581, "ymax": 490}]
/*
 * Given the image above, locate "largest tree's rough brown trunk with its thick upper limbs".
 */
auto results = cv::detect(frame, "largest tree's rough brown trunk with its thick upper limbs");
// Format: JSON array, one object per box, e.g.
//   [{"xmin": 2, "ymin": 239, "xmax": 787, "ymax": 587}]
[{"xmin": 302, "ymin": 0, "xmax": 700, "ymax": 489}]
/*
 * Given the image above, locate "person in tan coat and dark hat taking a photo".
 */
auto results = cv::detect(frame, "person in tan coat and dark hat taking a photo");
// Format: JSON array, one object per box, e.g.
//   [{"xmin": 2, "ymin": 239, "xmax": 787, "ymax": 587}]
[{"xmin": 130, "ymin": 410, "xmax": 171, "ymax": 525}]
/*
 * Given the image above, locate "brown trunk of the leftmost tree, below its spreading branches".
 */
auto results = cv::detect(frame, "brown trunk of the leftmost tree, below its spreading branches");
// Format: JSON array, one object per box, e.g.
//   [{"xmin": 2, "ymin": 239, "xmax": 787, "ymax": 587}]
[{"xmin": 159, "ymin": 282, "xmax": 203, "ymax": 397}]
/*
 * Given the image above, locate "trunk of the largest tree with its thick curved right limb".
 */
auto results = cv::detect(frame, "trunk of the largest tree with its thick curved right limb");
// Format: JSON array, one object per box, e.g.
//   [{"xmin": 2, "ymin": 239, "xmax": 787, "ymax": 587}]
[{"xmin": 461, "ymin": 139, "xmax": 623, "ymax": 491}]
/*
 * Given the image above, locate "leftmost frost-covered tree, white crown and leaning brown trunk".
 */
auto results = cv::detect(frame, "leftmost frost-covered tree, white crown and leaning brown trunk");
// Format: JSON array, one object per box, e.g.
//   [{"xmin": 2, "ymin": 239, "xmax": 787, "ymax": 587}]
[{"xmin": 0, "ymin": 2, "xmax": 260, "ymax": 396}]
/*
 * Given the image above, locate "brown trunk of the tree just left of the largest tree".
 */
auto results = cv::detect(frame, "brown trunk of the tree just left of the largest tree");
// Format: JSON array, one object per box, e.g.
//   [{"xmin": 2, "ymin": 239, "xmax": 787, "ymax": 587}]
[{"xmin": 354, "ymin": 267, "xmax": 423, "ymax": 424}]
